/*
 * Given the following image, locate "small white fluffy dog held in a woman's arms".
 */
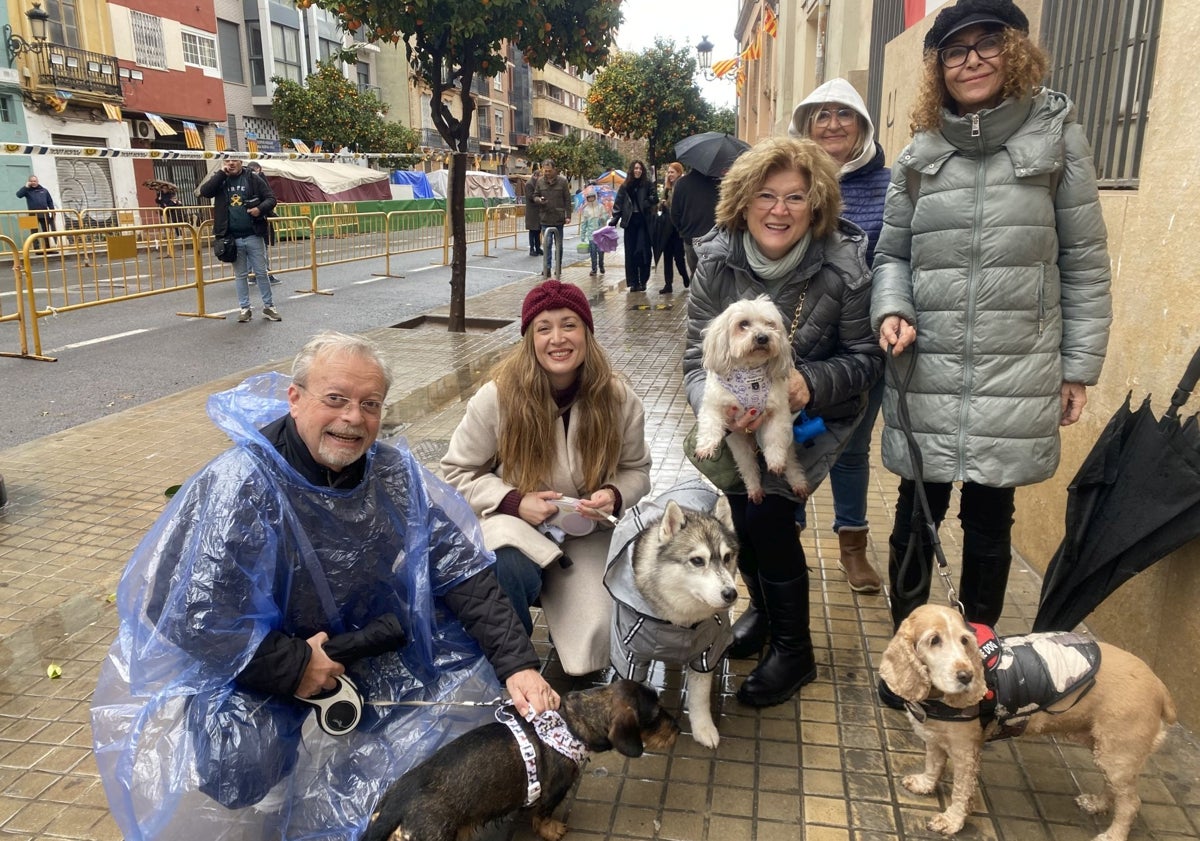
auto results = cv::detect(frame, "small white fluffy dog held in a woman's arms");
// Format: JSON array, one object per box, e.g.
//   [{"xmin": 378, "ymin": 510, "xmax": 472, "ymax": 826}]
[{"xmin": 696, "ymin": 295, "xmax": 809, "ymax": 503}]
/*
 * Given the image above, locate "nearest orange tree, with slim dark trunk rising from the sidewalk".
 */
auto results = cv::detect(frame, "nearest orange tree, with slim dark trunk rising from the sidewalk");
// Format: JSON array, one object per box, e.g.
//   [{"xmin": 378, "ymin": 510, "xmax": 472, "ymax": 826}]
[{"xmin": 296, "ymin": 0, "xmax": 622, "ymax": 332}]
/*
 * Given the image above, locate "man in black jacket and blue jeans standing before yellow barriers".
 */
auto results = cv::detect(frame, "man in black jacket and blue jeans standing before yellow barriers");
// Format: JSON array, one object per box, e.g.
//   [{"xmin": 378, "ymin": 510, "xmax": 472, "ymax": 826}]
[{"xmin": 199, "ymin": 158, "xmax": 283, "ymax": 324}]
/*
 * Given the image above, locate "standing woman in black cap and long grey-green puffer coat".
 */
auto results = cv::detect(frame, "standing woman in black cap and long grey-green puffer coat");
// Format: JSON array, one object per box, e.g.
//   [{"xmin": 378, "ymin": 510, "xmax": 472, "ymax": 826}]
[{"xmin": 871, "ymin": 0, "xmax": 1112, "ymax": 703}]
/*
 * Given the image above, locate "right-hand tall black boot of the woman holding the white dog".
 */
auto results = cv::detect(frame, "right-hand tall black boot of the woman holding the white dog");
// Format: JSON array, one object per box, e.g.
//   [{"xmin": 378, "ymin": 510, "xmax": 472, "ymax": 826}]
[{"xmin": 738, "ymin": 573, "xmax": 817, "ymax": 707}]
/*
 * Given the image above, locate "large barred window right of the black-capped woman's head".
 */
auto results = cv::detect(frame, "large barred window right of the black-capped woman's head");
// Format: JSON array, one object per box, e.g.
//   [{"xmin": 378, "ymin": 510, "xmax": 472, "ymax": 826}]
[{"xmin": 1042, "ymin": 0, "xmax": 1163, "ymax": 188}]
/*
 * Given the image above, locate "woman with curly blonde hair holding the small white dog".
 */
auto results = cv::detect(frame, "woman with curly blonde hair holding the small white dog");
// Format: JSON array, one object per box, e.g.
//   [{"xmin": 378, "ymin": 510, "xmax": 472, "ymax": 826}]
[{"xmin": 683, "ymin": 137, "xmax": 883, "ymax": 707}]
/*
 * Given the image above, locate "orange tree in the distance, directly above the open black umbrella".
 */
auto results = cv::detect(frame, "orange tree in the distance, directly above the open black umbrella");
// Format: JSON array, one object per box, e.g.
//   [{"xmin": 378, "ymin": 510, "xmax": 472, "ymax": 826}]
[{"xmin": 587, "ymin": 38, "xmax": 712, "ymax": 164}]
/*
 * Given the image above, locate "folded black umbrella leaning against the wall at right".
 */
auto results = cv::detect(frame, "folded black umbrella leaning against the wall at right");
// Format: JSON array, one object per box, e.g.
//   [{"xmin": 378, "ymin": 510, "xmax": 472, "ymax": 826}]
[{"xmin": 1033, "ymin": 350, "xmax": 1200, "ymax": 631}]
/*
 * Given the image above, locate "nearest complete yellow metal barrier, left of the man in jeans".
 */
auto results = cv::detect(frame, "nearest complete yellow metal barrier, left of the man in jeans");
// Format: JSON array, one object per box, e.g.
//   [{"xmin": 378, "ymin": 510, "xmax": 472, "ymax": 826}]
[{"xmin": 20, "ymin": 226, "xmax": 208, "ymax": 356}]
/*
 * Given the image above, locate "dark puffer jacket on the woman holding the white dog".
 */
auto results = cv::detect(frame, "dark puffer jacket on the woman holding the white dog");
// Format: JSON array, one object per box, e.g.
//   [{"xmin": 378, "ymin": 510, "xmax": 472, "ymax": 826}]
[{"xmin": 683, "ymin": 220, "xmax": 883, "ymax": 498}]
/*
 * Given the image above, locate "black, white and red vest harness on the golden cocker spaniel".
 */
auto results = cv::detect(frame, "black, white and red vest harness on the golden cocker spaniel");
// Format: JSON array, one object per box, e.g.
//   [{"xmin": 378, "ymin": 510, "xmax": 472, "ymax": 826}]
[{"xmin": 906, "ymin": 623, "xmax": 1100, "ymax": 741}]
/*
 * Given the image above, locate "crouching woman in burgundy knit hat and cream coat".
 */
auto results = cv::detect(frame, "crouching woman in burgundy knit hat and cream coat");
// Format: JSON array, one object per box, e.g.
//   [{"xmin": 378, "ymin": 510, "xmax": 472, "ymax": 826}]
[{"xmin": 442, "ymin": 280, "xmax": 650, "ymax": 674}]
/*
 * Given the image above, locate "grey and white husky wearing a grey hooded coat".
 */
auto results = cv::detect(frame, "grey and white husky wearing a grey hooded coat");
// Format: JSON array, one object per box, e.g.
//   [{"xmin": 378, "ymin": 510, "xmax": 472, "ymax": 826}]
[{"xmin": 605, "ymin": 482, "xmax": 738, "ymax": 747}]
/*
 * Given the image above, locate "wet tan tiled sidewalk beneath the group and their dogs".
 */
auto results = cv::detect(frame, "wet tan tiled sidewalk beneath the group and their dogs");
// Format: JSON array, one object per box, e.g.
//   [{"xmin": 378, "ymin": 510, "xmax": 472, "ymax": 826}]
[{"xmin": 0, "ymin": 254, "xmax": 1200, "ymax": 841}]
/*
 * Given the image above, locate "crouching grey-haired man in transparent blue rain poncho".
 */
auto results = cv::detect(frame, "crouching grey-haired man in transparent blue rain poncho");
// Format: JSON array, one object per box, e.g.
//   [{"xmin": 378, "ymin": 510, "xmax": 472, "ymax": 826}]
[{"xmin": 92, "ymin": 332, "xmax": 558, "ymax": 841}]
